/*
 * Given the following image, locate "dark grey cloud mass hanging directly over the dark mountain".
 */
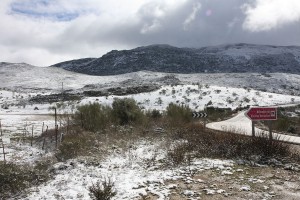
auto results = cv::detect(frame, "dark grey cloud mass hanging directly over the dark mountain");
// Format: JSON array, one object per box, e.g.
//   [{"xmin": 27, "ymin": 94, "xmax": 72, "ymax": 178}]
[{"xmin": 101, "ymin": 0, "xmax": 300, "ymax": 47}]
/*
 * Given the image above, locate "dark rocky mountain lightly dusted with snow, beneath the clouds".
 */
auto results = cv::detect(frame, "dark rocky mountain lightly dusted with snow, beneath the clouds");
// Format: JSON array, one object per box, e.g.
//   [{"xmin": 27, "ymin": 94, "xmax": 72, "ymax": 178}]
[{"xmin": 52, "ymin": 44, "xmax": 300, "ymax": 75}]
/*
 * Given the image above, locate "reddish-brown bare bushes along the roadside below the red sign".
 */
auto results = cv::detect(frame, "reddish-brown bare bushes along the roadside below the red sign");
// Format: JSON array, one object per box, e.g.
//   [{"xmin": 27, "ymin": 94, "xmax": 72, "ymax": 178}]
[{"xmin": 173, "ymin": 124, "xmax": 293, "ymax": 162}]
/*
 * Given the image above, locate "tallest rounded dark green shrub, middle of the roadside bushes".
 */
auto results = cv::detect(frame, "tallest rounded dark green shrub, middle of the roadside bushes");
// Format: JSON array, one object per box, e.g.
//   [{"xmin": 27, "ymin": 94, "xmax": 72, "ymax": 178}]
[{"xmin": 112, "ymin": 98, "xmax": 145, "ymax": 125}]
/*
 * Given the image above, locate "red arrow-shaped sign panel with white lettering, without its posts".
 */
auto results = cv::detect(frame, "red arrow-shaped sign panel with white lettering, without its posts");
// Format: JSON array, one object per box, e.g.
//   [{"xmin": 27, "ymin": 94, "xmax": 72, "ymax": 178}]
[{"xmin": 245, "ymin": 107, "xmax": 277, "ymax": 121}]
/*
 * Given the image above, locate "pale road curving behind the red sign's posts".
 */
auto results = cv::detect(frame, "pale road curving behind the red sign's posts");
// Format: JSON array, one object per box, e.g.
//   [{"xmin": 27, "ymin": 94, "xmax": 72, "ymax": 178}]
[{"xmin": 206, "ymin": 111, "xmax": 300, "ymax": 145}]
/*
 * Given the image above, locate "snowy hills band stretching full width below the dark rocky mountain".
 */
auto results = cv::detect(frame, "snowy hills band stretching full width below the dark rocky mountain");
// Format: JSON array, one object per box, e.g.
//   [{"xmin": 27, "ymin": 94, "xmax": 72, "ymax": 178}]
[{"xmin": 0, "ymin": 63, "xmax": 300, "ymax": 95}]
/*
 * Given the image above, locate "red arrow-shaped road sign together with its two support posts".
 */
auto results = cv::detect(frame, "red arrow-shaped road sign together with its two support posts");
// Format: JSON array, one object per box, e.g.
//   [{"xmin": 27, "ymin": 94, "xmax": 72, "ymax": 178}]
[{"xmin": 245, "ymin": 107, "xmax": 277, "ymax": 141}]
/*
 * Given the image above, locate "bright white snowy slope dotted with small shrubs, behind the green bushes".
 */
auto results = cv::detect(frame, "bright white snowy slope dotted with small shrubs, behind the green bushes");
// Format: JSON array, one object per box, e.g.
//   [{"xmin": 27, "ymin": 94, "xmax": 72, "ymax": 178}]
[{"xmin": 82, "ymin": 85, "xmax": 300, "ymax": 111}]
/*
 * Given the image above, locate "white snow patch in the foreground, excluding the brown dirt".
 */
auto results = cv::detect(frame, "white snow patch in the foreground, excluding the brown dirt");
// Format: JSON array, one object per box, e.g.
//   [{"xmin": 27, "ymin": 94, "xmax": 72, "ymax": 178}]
[{"xmin": 22, "ymin": 141, "xmax": 233, "ymax": 200}]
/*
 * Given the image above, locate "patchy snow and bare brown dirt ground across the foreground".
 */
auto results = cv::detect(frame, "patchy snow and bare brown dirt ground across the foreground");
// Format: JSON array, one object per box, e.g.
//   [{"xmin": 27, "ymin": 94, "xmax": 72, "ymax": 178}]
[{"xmin": 24, "ymin": 140, "xmax": 300, "ymax": 200}]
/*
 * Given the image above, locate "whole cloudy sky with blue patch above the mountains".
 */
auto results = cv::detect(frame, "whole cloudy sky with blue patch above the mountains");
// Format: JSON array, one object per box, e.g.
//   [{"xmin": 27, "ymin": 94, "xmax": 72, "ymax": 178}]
[{"xmin": 0, "ymin": 0, "xmax": 300, "ymax": 66}]
